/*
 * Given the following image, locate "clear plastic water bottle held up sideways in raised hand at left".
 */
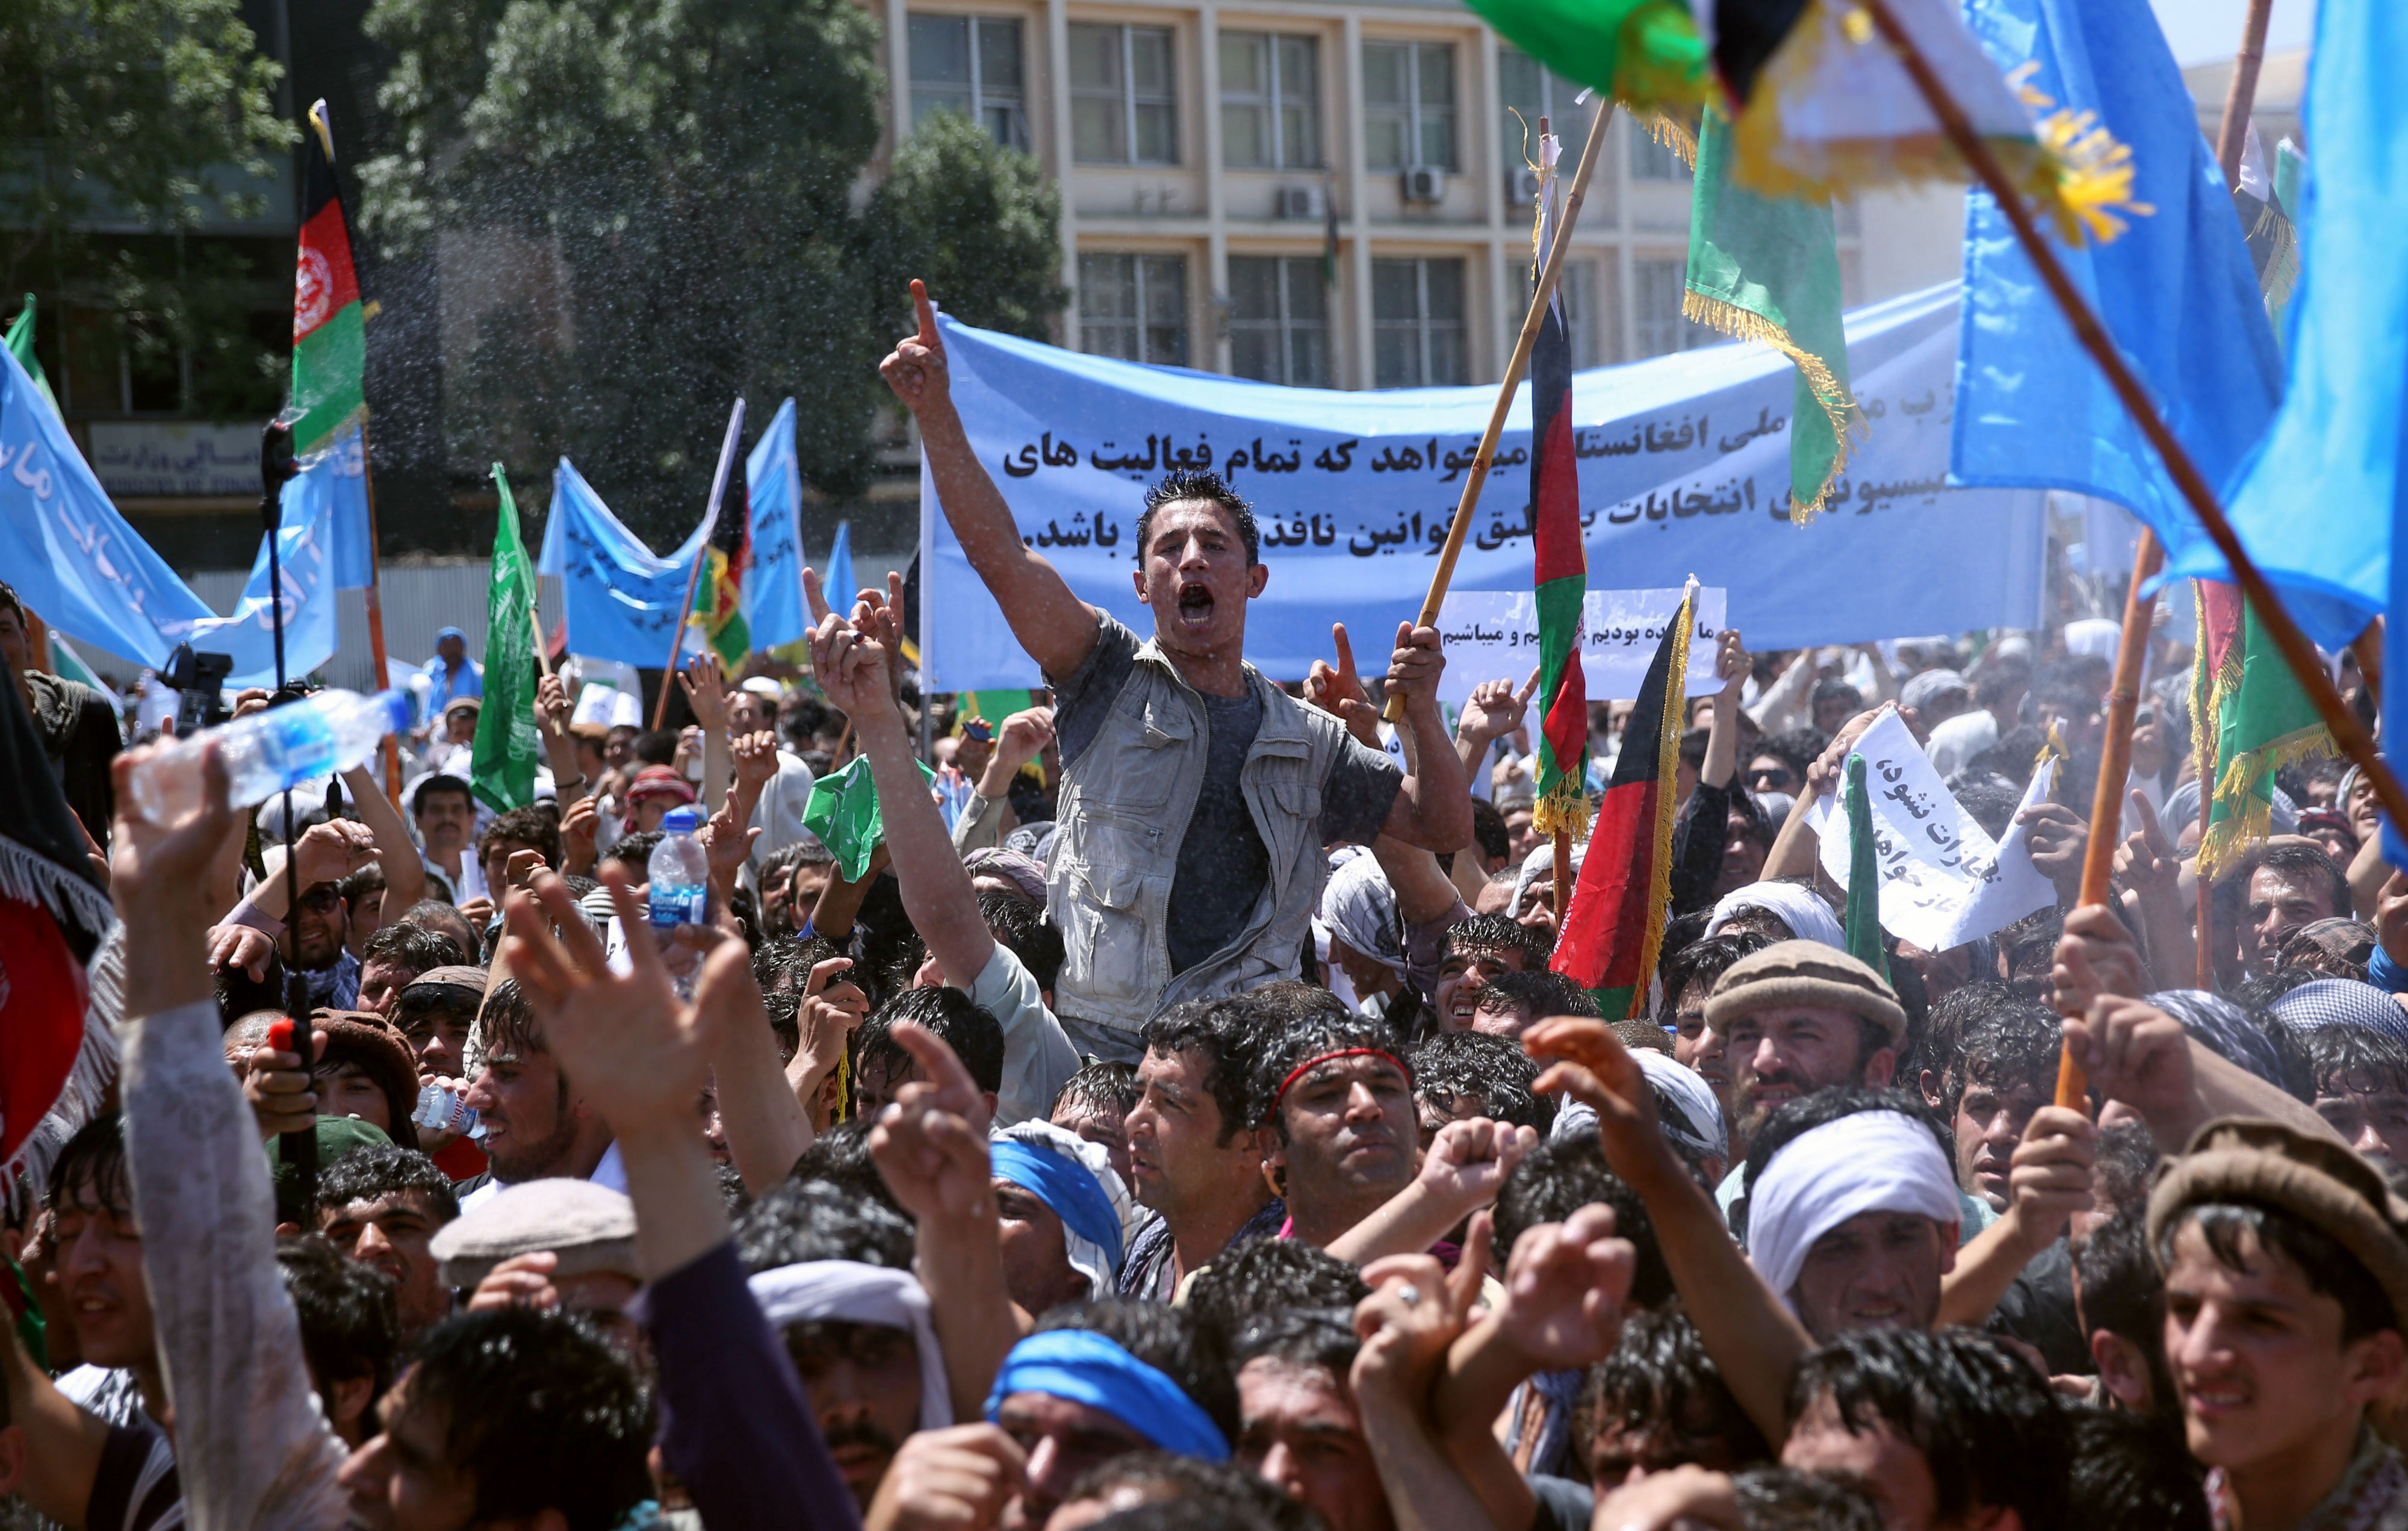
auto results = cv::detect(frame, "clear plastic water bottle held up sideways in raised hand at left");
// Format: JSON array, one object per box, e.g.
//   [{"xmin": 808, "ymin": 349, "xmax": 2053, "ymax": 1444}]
[{"xmin": 132, "ymin": 691, "xmax": 409, "ymax": 823}]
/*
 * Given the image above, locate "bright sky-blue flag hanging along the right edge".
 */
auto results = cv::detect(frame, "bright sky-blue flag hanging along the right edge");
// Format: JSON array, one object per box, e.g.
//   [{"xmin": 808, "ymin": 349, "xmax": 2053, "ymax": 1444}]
[{"xmin": 2172, "ymin": 0, "xmax": 2408, "ymax": 650}]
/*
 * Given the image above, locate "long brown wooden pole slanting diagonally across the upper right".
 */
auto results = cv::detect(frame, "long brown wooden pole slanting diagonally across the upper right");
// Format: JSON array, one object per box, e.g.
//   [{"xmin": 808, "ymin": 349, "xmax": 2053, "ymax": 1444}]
[{"xmin": 1864, "ymin": 0, "xmax": 2408, "ymax": 895}]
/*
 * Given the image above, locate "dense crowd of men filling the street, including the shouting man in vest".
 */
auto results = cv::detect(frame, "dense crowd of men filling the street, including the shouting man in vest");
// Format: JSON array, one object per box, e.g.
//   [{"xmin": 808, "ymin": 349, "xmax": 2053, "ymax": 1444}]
[{"xmin": 14, "ymin": 296, "xmax": 2408, "ymax": 1531}]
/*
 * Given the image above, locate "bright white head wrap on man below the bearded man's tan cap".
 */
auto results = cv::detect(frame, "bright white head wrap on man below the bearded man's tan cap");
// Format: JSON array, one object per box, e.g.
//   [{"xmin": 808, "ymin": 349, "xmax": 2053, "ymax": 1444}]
[{"xmin": 1748, "ymin": 1112, "xmax": 1965, "ymax": 1312}]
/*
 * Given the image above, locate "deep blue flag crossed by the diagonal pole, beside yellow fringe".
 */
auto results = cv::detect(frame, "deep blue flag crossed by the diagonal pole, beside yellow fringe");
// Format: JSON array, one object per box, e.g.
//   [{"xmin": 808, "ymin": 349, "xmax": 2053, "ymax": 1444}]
[{"xmin": 1955, "ymin": 0, "xmax": 2283, "ymax": 589}]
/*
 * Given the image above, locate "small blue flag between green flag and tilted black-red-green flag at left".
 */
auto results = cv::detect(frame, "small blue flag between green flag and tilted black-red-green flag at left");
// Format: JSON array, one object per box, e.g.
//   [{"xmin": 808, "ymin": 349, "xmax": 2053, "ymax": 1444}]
[{"xmin": 535, "ymin": 458, "xmax": 703, "ymax": 667}]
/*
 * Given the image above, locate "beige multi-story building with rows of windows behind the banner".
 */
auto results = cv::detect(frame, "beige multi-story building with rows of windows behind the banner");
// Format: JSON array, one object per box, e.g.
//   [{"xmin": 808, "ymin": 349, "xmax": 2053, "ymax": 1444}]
[{"xmin": 874, "ymin": 0, "xmax": 1960, "ymax": 388}]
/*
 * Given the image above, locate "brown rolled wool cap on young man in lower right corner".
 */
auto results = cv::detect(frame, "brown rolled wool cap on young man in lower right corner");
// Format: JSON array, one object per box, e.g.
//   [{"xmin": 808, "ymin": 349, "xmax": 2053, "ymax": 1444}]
[{"xmin": 2148, "ymin": 1117, "xmax": 2408, "ymax": 1331}]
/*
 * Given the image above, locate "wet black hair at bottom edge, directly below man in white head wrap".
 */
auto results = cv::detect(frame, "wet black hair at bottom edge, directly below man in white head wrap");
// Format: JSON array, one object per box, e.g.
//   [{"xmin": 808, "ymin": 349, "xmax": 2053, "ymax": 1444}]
[{"xmin": 1789, "ymin": 1329, "xmax": 2073, "ymax": 1531}]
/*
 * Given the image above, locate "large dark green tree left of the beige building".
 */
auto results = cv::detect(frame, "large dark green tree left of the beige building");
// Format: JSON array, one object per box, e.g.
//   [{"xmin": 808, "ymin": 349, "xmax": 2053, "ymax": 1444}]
[{"xmin": 361, "ymin": 0, "xmax": 1062, "ymax": 542}]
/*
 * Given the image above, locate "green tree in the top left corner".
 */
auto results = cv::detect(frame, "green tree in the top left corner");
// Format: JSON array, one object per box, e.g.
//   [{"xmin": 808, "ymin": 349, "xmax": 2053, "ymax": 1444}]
[{"xmin": 0, "ymin": 0, "xmax": 296, "ymax": 417}]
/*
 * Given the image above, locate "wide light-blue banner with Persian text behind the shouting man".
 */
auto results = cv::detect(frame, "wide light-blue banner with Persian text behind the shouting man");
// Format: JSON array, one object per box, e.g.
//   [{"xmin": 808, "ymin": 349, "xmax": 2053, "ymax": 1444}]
[{"xmin": 922, "ymin": 282, "xmax": 2044, "ymax": 691}]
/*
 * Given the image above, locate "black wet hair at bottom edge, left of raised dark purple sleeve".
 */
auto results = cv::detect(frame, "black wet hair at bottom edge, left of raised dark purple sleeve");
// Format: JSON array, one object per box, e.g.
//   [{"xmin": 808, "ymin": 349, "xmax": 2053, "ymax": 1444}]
[{"xmin": 407, "ymin": 1307, "xmax": 653, "ymax": 1531}]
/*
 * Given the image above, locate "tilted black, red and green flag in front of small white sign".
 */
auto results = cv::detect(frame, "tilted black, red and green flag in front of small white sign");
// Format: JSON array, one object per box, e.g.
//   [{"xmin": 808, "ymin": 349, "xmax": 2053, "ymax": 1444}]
[{"xmin": 1551, "ymin": 588, "xmax": 1698, "ymax": 1020}]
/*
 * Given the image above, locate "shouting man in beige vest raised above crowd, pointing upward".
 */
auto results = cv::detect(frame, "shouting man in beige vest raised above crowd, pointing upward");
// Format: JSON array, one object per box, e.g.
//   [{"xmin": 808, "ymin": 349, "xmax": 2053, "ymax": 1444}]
[{"xmin": 879, "ymin": 282, "xmax": 1471, "ymax": 1061}]
